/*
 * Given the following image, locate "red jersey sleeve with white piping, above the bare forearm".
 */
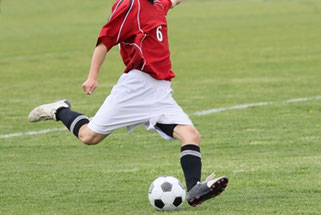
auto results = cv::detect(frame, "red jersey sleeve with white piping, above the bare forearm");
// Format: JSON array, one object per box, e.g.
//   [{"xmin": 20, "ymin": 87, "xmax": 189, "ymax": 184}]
[{"xmin": 97, "ymin": 0, "xmax": 137, "ymax": 51}]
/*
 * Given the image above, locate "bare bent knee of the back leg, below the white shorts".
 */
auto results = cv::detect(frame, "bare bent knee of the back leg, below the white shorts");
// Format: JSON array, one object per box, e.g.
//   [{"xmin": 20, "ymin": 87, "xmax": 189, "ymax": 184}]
[{"xmin": 78, "ymin": 124, "xmax": 109, "ymax": 145}]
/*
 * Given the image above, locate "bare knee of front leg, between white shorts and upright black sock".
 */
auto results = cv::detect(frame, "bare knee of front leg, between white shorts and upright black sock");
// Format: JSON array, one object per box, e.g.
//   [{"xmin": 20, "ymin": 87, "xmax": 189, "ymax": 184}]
[{"xmin": 173, "ymin": 125, "xmax": 201, "ymax": 146}]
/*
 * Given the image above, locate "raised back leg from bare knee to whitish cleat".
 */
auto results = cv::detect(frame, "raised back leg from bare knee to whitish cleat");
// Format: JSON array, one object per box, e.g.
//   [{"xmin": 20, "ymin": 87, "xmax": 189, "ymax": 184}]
[{"xmin": 28, "ymin": 99, "xmax": 108, "ymax": 145}]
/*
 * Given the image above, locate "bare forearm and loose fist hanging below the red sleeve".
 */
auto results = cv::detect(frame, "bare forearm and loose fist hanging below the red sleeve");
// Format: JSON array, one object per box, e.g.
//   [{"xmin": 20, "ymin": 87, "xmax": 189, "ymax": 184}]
[{"xmin": 82, "ymin": 43, "xmax": 107, "ymax": 95}]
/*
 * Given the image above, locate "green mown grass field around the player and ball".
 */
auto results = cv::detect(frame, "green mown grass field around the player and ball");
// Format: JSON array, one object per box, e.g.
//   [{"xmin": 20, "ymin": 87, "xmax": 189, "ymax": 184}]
[{"xmin": 0, "ymin": 0, "xmax": 321, "ymax": 215}]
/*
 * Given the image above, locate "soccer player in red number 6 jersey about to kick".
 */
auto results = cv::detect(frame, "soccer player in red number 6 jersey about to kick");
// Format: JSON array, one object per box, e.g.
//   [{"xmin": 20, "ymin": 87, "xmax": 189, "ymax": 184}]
[{"xmin": 28, "ymin": 0, "xmax": 228, "ymax": 206}]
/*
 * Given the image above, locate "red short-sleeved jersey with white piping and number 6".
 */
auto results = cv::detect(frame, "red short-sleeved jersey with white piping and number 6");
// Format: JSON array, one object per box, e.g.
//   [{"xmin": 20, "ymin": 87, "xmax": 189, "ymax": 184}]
[{"xmin": 97, "ymin": 0, "xmax": 175, "ymax": 81}]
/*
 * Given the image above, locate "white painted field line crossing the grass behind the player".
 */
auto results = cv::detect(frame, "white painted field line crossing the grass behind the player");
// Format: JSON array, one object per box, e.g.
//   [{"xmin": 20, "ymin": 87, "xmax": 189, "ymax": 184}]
[{"xmin": 0, "ymin": 96, "xmax": 321, "ymax": 139}]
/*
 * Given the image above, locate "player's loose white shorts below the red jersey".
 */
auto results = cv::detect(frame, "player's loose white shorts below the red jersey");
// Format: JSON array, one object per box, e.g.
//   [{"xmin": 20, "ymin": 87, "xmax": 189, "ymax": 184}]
[{"xmin": 88, "ymin": 70, "xmax": 193, "ymax": 140}]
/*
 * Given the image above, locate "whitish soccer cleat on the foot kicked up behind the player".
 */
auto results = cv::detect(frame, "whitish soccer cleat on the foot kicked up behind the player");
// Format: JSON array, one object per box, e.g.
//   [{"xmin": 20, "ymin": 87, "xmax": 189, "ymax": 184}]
[{"xmin": 28, "ymin": 99, "xmax": 71, "ymax": 122}]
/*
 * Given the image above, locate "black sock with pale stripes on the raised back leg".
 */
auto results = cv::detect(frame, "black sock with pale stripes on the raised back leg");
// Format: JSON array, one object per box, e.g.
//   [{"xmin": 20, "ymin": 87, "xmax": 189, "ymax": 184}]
[{"xmin": 56, "ymin": 108, "xmax": 89, "ymax": 137}]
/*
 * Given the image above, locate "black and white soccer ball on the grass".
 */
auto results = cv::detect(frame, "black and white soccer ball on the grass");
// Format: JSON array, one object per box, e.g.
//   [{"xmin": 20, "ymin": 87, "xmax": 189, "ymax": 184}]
[{"xmin": 148, "ymin": 176, "xmax": 186, "ymax": 211}]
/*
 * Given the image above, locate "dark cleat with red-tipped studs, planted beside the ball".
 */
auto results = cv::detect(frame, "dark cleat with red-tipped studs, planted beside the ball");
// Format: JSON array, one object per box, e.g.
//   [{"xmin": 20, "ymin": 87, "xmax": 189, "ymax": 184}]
[{"xmin": 187, "ymin": 173, "xmax": 228, "ymax": 207}]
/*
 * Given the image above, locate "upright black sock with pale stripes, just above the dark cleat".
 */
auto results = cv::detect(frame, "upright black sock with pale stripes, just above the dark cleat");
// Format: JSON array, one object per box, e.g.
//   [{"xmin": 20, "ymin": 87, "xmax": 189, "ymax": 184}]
[{"xmin": 181, "ymin": 145, "xmax": 202, "ymax": 191}]
